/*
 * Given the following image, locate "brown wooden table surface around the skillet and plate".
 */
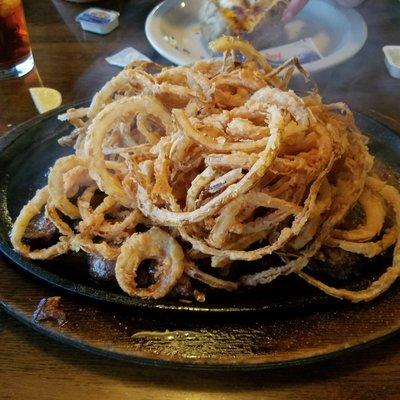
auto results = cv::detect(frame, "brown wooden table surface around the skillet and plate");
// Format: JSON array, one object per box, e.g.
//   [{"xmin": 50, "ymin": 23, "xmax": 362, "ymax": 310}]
[{"xmin": 0, "ymin": 0, "xmax": 400, "ymax": 400}]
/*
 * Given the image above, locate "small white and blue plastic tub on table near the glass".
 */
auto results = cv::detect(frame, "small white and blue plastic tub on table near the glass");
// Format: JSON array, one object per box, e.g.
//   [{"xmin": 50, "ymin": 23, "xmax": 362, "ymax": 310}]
[{"xmin": 75, "ymin": 7, "xmax": 119, "ymax": 35}]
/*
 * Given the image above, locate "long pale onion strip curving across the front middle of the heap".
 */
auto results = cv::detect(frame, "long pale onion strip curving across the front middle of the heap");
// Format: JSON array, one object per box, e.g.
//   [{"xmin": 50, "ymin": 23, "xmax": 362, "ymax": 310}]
[{"xmin": 137, "ymin": 106, "xmax": 282, "ymax": 226}]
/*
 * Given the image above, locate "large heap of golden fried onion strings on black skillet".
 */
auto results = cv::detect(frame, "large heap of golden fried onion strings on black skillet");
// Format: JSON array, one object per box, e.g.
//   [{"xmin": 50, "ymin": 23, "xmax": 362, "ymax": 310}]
[{"xmin": 11, "ymin": 37, "xmax": 400, "ymax": 302}]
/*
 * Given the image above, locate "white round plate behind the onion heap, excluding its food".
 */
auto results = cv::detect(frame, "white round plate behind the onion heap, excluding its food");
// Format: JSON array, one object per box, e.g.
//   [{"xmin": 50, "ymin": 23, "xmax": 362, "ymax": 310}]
[{"xmin": 146, "ymin": 0, "xmax": 367, "ymax": 72}]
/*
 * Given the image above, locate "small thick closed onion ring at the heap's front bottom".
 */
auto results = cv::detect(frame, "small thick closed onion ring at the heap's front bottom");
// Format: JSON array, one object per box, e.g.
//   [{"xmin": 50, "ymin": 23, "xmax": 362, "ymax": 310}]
[{"xmin": 115, "ymin": 227, "xmax": 185, "ymax": 299}]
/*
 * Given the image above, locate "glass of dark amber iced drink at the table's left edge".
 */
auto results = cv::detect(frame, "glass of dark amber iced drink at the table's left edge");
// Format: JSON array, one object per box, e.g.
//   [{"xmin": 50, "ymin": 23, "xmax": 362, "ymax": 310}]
[{"xmin": 0, "ymin": 0, "xmax": 34, "ymax": 79}]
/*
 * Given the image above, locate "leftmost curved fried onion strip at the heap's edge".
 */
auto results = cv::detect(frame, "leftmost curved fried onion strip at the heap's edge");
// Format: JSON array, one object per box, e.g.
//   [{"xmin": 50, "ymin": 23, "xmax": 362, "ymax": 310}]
[{"xmin": 10, "ymin": 186, "xmax": 69, "ymax": 260}]
